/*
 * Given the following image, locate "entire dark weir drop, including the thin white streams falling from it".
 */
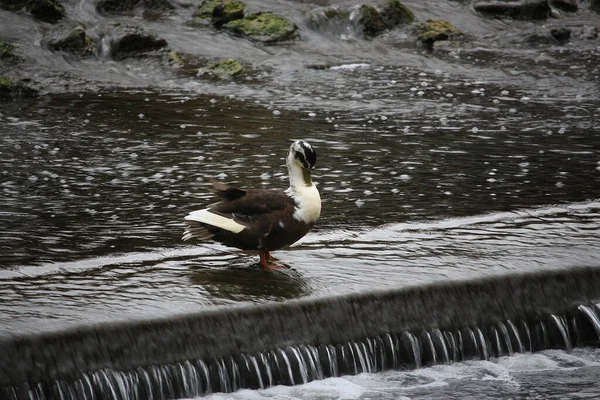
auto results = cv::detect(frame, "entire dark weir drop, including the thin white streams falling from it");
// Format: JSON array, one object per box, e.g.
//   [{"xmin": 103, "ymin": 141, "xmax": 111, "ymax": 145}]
[{"xmin": 0, "ymin": 268, "xmax": 600, "ymax": 399}]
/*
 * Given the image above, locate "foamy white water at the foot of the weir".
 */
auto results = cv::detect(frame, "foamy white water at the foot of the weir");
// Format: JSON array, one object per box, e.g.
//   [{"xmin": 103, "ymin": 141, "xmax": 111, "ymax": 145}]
[{"xmin": 202, "ymin": 349, "xmax": 600, "ymax": 400}]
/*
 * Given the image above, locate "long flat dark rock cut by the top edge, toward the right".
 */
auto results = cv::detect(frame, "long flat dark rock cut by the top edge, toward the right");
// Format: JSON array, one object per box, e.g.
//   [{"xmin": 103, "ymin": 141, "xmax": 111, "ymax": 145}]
[{"xmin": 473, "ymin": 0, "xmax": 552, "ymax": 20}]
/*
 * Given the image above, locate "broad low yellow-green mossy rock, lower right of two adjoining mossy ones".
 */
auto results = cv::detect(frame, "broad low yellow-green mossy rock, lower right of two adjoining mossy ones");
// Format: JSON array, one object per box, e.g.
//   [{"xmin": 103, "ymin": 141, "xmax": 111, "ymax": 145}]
[{"xmin": 223, "ymin": 12, "xmax": 298, "ymax": 43}]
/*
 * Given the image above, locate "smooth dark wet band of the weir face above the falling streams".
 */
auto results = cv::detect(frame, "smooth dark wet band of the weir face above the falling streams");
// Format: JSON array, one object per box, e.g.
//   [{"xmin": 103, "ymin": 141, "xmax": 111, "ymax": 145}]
[{"xmin": 0, "ymin": 268, "xmax": 600, "ymax": 388}]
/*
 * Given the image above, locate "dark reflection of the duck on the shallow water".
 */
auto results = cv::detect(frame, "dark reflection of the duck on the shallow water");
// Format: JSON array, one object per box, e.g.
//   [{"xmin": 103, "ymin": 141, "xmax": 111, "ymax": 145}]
[{"xmin": 190, "ymin": 264, "xmax": 313, "ymax": 303}]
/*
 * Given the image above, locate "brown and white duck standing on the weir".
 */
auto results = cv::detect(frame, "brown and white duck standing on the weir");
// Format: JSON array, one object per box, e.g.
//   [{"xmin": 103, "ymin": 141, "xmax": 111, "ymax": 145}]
[{"xmin": 182, "ymin": 140, "xmax": 321, "ymax": 270}]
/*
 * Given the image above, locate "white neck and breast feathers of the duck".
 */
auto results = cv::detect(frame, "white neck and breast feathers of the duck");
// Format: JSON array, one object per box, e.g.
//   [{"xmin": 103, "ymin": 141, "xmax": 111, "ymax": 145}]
[{"xmin": 286, "ymin": 155, "xmax": 321, "ymax": 224}]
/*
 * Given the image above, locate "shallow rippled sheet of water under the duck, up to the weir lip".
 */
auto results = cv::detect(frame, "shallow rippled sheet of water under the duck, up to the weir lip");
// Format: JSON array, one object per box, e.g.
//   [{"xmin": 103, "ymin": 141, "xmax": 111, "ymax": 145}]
[{"xmin": 0, "ymin": 202, "xmax": 600, "ymax": 331}]
